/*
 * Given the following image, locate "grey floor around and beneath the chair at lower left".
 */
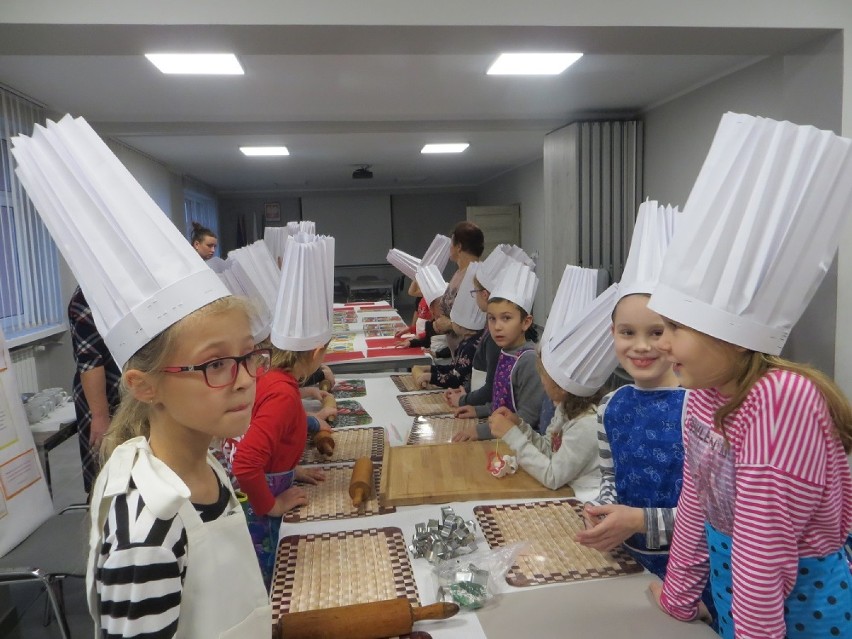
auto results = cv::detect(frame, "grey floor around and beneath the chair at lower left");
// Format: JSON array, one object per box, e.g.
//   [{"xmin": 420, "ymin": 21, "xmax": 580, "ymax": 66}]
[{"xmin": 0, "ymin": 438, "xmax": 94, "ymax": 639}]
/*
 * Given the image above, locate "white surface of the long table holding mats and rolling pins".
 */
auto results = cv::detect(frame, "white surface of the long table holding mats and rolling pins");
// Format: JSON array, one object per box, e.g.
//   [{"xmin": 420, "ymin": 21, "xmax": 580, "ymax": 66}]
[{"xmin": 288, "ymin": 373, "xmax": 716, "ymax": 639}]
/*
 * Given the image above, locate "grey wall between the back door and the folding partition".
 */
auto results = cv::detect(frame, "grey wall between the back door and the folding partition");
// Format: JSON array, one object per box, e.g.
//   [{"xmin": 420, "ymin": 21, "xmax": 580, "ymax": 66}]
[{"xmin": 476, "ymin": 158, "xmax": 547, "ymax": 312}]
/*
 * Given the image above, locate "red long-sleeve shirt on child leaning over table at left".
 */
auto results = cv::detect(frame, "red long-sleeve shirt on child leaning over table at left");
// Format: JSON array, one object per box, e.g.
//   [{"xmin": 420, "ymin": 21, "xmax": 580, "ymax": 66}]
[{"xmin": 232, "ymin": 368, "xmax": 308, "ymax": 515}]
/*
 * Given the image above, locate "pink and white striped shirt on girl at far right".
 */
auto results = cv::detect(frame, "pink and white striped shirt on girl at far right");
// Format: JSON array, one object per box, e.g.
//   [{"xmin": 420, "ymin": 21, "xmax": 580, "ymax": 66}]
[{"xmin": 661, "ymin": 370, "xmax": 852, "ymax": 639}]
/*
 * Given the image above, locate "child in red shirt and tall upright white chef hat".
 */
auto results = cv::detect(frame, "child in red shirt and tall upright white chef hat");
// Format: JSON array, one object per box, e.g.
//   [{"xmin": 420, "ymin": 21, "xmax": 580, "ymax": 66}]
[{"xmin": 230, "ymin": 231, "xmax": 334, "ymax": 586}]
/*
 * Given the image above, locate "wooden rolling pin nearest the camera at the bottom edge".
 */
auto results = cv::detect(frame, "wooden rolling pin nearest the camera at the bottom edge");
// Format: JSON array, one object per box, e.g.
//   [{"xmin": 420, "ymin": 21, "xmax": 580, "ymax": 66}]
[{"xmin": 275, "ymin": 599, "xmax": 459, "ymax": 639}]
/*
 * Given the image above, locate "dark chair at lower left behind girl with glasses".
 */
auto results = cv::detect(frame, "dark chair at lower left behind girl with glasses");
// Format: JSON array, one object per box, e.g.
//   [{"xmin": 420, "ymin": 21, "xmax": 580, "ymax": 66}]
[{"xmin": 0, "ymin": 504, "xmax": 89, "ymax": 639}]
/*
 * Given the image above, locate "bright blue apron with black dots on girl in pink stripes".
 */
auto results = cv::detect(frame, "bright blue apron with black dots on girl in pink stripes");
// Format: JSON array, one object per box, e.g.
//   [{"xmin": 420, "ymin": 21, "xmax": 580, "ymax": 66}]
[{"xmin": 704, "ymin": 523, "xmax": 852, "ymax": 639}]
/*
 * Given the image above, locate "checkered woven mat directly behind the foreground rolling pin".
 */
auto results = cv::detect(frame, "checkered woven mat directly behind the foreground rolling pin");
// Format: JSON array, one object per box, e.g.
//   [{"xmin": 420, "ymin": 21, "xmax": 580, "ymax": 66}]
[{"xmin": 270, "ymin": 528, "xmax": 420, "ymax": 623}]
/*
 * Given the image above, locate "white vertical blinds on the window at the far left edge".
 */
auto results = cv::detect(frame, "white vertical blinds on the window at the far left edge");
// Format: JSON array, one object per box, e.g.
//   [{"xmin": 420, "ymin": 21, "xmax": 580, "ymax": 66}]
[{"xmin": 0, "ymin": 88, "xmax": 66, "ymax": 347}]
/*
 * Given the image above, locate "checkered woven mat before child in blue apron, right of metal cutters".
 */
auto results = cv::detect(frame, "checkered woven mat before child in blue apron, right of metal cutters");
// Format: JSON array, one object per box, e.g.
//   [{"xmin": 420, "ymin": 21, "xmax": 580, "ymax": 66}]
[{"xmin": 473, "ymin": 499, "xmax": 642, "ymax": 586}]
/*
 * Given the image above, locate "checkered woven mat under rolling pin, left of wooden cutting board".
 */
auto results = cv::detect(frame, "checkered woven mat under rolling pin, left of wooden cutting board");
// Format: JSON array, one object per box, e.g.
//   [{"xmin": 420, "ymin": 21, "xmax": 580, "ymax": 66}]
[{"xmin": 284, "ymin": 464, "xmax": 396, "ymax": 523}]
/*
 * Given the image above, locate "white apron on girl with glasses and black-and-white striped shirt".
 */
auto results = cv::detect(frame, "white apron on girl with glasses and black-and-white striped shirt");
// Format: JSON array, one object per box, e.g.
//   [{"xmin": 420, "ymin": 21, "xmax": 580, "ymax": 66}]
[{"xmin": 86, "ymin": 437, "xmax": 272, "ymax": 639}]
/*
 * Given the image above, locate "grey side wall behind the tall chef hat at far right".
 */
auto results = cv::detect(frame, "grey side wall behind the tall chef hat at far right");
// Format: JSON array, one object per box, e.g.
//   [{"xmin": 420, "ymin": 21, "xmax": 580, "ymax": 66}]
[{"xmin": 645, "ymin": 34, "xmax": 843, "ymax": 375}]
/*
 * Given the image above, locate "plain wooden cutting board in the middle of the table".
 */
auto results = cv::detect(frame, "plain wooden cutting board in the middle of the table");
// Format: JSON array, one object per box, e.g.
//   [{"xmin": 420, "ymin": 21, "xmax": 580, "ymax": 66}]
[{"xmin": 379, "ymin": 441, "xmax": 574, "ymax": 506}]
